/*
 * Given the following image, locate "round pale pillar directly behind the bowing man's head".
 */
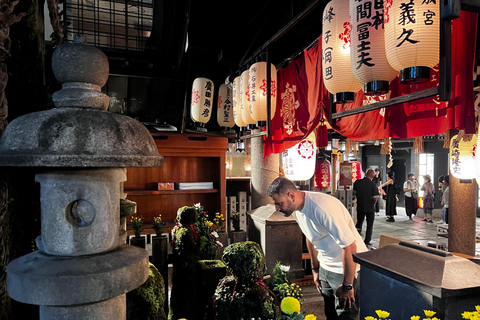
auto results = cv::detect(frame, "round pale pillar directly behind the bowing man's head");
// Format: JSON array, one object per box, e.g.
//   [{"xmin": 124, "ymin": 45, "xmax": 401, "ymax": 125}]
[{"xmin": 251, "ymin": 130, "xmax": 279, "ymax": 210}]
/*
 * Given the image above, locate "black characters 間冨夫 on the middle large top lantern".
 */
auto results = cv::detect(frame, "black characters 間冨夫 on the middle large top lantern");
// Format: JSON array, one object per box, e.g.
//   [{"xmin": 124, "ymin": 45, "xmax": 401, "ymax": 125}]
[{"xmin": 353, "ymin": 0, "xmax": 384, "ymax": 70}]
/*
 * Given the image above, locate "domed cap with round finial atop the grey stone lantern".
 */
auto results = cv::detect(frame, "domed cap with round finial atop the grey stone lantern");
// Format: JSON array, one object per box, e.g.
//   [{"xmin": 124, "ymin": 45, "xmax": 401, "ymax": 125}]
[{"xmin": 0, "ymin": 37, "xmax": 163, "ymax": 167}]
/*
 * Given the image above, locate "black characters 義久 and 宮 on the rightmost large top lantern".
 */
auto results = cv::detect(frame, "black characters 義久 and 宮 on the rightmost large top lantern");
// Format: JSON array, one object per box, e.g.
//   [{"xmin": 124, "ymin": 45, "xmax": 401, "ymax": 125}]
[{"xmin": 397, "ymin": 0, "xmax": 436, "ymax": 47}]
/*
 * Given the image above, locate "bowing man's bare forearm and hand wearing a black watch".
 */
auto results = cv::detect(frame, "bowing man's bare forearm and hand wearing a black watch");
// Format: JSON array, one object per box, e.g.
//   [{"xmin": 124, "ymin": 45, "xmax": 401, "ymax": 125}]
[{"xmin": 336, "ymin": 242, "xmax": 357, "ymax": 309}]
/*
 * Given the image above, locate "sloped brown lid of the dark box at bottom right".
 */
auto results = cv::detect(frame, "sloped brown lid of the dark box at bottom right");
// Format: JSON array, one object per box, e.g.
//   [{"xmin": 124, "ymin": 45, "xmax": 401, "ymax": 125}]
[{"xmin": 354, "ymin": 241, "xmax": 480, "ymax": 298}]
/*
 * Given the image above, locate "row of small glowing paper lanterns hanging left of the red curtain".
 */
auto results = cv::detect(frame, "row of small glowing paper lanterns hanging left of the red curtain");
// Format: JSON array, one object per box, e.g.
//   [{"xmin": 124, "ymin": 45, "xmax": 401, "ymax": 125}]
[{"xmin": 190, "ymin": 62, "xmax": 277, "ymax": 130}]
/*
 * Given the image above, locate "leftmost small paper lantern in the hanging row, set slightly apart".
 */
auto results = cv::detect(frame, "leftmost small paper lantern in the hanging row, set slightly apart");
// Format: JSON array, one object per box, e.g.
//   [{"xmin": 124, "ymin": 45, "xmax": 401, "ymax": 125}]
[{"xmin": 190, "ymin": 78, "xmax": 214, "ymax": 124}]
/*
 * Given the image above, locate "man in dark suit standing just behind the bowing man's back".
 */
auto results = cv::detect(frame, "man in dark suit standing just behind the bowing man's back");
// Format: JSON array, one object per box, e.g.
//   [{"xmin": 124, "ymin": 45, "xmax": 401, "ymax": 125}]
[{"xmin": 353, "ymin": 169, "xmax": 379, "ymax": 246}]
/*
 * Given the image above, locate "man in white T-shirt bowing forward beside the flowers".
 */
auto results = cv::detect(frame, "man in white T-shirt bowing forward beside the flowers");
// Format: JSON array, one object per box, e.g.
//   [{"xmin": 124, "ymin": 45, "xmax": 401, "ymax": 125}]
[{"xmin": 267, "ymin": 177, "xmax": 367, "ymax": 320}]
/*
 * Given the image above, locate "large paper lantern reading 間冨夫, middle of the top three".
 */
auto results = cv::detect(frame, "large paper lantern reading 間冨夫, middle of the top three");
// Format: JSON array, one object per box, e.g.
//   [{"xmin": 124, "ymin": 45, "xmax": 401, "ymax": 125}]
[{"xmin": 350, "ymin": 0, "xmax": 398, "ymax": 95}]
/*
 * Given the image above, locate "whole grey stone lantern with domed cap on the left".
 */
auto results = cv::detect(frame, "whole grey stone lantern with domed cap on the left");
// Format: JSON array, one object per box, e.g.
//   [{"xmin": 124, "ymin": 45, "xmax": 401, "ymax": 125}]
[{"xmin": 0, "ymin": 37, "xmax": 163, "ymax": 320}]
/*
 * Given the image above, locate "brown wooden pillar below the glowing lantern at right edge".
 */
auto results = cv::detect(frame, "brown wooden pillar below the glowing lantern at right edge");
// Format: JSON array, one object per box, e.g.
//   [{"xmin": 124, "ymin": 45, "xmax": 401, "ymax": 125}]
[{"xmin": 448, "ymin": 174, "xmax": 477, "ymax": 256}]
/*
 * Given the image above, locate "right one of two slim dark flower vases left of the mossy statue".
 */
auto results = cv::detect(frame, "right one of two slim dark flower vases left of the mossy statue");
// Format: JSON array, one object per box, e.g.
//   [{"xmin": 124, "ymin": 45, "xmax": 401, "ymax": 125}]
[{"xmin": 152, "ymin": 214, "xmax": 168, "ymax": 313}]
